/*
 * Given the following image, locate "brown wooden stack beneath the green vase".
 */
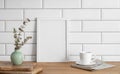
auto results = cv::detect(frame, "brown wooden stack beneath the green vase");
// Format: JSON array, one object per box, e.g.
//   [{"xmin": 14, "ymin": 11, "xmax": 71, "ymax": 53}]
[{"xmin": 0, "ymin": 62, "xmax": 42, "ymax": 74}]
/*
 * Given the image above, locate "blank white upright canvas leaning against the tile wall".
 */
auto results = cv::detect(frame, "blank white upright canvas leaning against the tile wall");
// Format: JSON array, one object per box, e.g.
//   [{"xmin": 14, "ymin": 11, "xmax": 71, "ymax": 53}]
[{"xmin": 37, "ymin": 18, "xmax": 66, "ymax": 62}]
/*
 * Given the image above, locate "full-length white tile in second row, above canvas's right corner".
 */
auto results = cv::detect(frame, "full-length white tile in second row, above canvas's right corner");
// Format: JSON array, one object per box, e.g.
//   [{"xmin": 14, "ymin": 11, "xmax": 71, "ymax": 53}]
[{"xmin": 63, "ymin": 9, "xmax": 100, "ymax": 20}]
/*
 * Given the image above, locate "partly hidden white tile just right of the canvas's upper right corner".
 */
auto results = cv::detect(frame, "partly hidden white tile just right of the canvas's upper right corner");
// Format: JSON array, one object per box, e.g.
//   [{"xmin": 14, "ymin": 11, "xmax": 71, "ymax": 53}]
[{"xmin": 67, "ymin": 21, "xmax": 81, "ymax": 31}]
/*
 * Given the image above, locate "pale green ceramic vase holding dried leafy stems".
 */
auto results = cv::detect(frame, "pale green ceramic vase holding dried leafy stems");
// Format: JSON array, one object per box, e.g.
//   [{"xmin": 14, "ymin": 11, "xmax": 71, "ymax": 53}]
[{"xmin": 11, "ymin": 49, "xmax": 24, "ymax": 65}]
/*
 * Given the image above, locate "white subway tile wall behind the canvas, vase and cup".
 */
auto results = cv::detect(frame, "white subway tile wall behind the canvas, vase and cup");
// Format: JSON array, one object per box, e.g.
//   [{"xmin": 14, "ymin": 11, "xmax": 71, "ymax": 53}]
[{"xmin": 0, "ymin": 0, "xmax": 120, "ymax": 61}]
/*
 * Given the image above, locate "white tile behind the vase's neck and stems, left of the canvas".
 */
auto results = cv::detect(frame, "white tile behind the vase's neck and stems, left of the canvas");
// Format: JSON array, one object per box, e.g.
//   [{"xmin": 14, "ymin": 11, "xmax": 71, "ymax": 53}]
[{"xmin": 6, "ymin": 44, "xmax": 36, "ymax": 55}]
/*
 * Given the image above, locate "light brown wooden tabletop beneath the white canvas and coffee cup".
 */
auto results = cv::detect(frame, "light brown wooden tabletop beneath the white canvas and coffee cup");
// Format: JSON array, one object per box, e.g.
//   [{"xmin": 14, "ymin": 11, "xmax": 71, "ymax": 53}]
[{"xmin": 37, "ymin": 62, "xmax": 120, "ymax": 74}]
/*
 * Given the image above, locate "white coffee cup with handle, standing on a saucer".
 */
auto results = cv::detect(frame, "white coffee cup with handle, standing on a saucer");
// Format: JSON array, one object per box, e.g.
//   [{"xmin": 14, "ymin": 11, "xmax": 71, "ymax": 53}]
[{"xmin": 80, "ymin": 52, "xmax": 95, "ymax": 65}]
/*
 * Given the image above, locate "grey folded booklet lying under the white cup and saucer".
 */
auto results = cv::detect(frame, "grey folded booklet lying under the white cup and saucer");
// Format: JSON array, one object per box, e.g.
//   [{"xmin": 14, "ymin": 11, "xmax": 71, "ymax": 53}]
[{"xmin": 71, "ymin": 59, "xmax": 115, "ymax": 71}]
